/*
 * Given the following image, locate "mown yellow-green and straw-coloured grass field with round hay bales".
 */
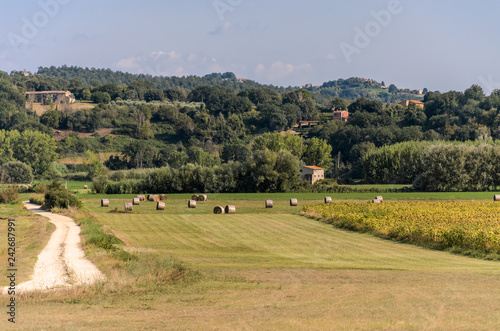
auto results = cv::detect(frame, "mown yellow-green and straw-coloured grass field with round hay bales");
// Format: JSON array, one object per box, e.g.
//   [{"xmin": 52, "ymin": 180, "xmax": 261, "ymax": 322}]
[{"xmin": 0, "ymin": 193, "xmax": 500, "ymax": 330}]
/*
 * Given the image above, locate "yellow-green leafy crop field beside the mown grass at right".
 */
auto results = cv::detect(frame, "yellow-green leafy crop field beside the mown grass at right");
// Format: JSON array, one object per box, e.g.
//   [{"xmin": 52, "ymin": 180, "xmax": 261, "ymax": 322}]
[{"xmin": 304, "ymin": 201, "xmax": 500, "ymax": 257}]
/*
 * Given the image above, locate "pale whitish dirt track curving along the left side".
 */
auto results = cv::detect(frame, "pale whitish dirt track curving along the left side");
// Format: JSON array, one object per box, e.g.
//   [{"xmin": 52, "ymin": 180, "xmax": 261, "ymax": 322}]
[{"xmin": 2, "ymin": 202, "xmax": 105, "ymax": 294}]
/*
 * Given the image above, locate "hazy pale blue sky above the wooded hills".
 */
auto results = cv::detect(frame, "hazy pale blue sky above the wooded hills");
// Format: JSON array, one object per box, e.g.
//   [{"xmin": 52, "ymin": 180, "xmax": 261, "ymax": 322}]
[{"xmin": 0, "ymin": 0, "xmax": 500, "ymax": 94}]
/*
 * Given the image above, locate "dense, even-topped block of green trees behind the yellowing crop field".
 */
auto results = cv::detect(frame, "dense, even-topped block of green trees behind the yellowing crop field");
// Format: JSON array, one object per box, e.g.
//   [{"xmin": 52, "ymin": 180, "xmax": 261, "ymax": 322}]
[{"xmin": 363, "ymin": 141, "xmax": 500, "ymax": 191}]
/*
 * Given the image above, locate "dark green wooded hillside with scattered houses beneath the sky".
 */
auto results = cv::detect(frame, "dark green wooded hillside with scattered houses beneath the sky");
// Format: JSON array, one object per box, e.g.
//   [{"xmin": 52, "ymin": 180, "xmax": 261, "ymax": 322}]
[{"xmin": 0, "ymin": 67, "xmax": 500, "ymax": 190}]
